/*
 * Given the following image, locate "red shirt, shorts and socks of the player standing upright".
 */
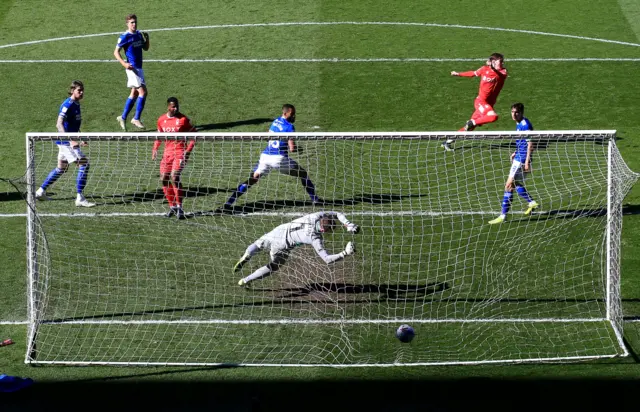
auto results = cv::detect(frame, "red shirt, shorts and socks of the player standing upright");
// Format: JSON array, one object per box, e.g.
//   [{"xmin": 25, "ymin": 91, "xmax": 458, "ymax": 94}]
[{"xmin": 153, "ymin": 113, "xmax": 196, "ymax": 208}]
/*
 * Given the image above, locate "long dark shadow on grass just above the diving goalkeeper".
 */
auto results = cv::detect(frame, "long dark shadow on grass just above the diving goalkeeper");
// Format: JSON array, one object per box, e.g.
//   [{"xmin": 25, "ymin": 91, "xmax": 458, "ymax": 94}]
[{"xmin": 198, "ymin": 193, "xmax": 428, "ymax": 217}]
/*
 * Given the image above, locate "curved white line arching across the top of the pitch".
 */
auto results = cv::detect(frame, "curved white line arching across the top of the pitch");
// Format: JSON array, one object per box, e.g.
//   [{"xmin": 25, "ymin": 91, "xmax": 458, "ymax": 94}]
[{"xmin": 0, "ymin": 21, "xmax": 640, "ymax": 49}]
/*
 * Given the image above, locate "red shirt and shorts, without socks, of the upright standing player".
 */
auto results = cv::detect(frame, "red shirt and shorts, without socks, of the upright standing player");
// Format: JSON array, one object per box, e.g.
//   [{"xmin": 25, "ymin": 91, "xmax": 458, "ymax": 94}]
[{"xmin": 153, "ymin": 113, "xmax": 195, "ymax": 174}]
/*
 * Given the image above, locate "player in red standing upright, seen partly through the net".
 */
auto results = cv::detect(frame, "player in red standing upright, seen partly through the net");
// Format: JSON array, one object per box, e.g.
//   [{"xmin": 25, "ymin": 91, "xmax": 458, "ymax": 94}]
[{"xmin": 151, "ymin": 97, "xmax": 196, "ymax": 219}]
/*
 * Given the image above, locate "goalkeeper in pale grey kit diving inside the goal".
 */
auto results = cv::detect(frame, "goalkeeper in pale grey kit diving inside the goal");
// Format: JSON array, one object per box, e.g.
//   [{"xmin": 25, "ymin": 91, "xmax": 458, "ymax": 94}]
[{"xmin": 233, "ymin": 212, "xmax": 360, "ymax": 286}]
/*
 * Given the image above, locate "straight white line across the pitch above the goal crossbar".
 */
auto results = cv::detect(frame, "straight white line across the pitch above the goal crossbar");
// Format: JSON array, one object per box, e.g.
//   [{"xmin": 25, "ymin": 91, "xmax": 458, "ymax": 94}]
[{"xmin": 0, "ymin": 57, "xmax": 640, "ymax": 64}]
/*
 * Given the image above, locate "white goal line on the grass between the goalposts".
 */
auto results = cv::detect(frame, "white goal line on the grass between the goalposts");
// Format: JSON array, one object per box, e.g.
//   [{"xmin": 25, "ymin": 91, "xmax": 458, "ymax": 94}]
[{"xmin": 42, "ymin": 318, "xmax": 609, "ymax": 325}]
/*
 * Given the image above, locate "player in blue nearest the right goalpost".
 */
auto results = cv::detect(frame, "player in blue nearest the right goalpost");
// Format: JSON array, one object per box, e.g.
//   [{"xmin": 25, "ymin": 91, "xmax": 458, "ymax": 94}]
[{"xmin": 489, "ymin": 103, "xmax": 538, "ymax": 225}]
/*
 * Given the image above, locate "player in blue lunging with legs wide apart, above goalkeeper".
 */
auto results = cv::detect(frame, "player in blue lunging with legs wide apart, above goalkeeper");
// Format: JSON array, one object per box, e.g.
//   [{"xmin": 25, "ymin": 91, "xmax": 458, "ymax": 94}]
[{"xmin": 223, "ymin": 104, "xmax": 321, "ymax": 211}]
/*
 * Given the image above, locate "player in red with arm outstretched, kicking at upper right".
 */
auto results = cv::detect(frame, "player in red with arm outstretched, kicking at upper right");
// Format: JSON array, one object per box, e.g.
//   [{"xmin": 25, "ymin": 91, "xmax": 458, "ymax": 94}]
[{"xmin": 442, "ymin": 53, "xmax": 507, "ymax": 151}]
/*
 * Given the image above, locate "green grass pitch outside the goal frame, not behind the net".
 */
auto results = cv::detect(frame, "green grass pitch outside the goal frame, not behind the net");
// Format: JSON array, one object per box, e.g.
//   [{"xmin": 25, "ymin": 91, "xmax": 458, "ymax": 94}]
[{"xmin": 0, "ymin": 1, "xmax": 640, "ymax": 406}]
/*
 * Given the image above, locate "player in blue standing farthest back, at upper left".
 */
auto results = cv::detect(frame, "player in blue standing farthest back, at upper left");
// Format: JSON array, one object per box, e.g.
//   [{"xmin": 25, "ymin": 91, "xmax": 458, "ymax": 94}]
[{"xmin": 113, "ymin": 14, "xmax": 149, "ymax": 131}]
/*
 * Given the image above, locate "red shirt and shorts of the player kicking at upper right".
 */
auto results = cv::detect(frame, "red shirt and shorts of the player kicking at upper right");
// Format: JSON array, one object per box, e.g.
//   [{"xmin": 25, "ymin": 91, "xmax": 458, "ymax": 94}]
[{"xmin": 460, "ymin": 66, "xmax": 508, "ymax": 126}]
